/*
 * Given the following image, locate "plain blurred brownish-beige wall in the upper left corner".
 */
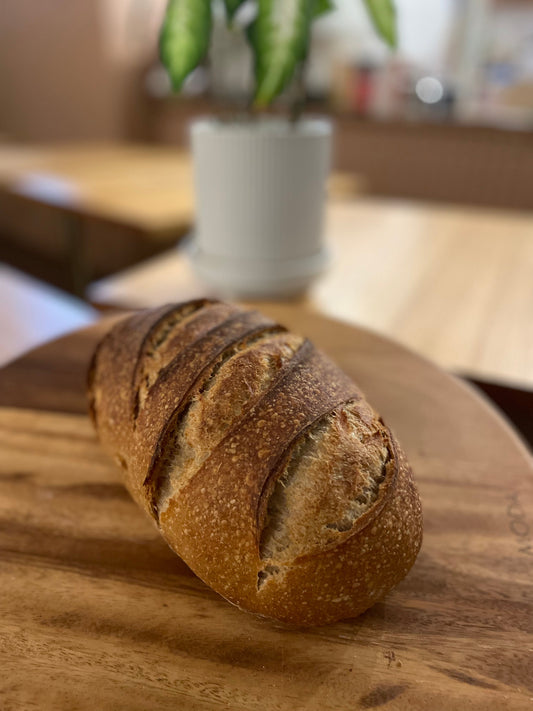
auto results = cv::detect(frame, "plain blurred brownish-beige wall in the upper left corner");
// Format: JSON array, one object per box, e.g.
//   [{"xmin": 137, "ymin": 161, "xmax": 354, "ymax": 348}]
[{"xmin": 0, "ymin": 0, "xmax": 150, "ymax": 141}]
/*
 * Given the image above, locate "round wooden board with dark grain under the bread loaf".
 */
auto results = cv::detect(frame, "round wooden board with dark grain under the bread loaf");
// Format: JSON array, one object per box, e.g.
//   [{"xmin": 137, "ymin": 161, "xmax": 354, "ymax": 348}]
[{"xmin": 0, "ymin": 306, "xmax": 533, "ymax": 711}]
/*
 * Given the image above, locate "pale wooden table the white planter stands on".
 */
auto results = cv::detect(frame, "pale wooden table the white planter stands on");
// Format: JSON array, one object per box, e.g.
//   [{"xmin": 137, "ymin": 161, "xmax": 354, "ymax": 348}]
[{"xmin": 88, "ymin": 199, "xmax": 533, "ymax": 388}]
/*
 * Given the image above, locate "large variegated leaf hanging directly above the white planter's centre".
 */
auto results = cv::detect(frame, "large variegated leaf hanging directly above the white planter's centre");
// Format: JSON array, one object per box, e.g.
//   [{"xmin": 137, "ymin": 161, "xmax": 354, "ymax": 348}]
[{"xmin": 248, "ymin": 0, "xmax": 315, "ymax": 106}]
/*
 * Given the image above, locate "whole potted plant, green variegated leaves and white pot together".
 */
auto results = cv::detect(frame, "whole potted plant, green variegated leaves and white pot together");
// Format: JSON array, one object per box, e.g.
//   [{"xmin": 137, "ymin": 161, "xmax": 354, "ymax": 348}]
[{"xmin": 160, "ymin": 0, "xmax": 396, "ymax": 298}]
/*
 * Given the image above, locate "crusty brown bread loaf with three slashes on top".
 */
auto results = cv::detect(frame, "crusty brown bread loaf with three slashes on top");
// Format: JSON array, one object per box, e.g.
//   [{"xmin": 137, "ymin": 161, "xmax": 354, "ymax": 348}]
[{"xmin": 89, "ymin": 300, "xmax": 422, "ymax": 625}]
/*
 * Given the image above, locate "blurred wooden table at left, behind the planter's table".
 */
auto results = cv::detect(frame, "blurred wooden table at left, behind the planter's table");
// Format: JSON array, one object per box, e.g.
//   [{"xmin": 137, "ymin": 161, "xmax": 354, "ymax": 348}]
[{"xmin": 0, "ymin": 143, "xmax": 193, "ymax": 294}]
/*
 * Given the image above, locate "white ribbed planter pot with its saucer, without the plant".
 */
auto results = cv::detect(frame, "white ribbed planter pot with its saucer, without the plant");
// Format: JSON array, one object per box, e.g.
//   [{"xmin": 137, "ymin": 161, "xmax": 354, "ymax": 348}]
[{"xmin": 191, "ymin": 118, "xmax": 332, "ymax": 298}]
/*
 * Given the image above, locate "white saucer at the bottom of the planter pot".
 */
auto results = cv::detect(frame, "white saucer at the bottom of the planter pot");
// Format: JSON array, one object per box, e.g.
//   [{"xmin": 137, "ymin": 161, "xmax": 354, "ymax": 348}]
[{"xmin": 191, "ymin": 248, "xmax": 330, "ymax": 299}]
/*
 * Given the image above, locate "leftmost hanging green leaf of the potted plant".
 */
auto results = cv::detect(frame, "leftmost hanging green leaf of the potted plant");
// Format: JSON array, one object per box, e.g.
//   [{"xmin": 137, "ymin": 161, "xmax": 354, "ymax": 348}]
[{"xmin": 159, "ymin": 0, "xmax": 212, "ymax": 91}]
